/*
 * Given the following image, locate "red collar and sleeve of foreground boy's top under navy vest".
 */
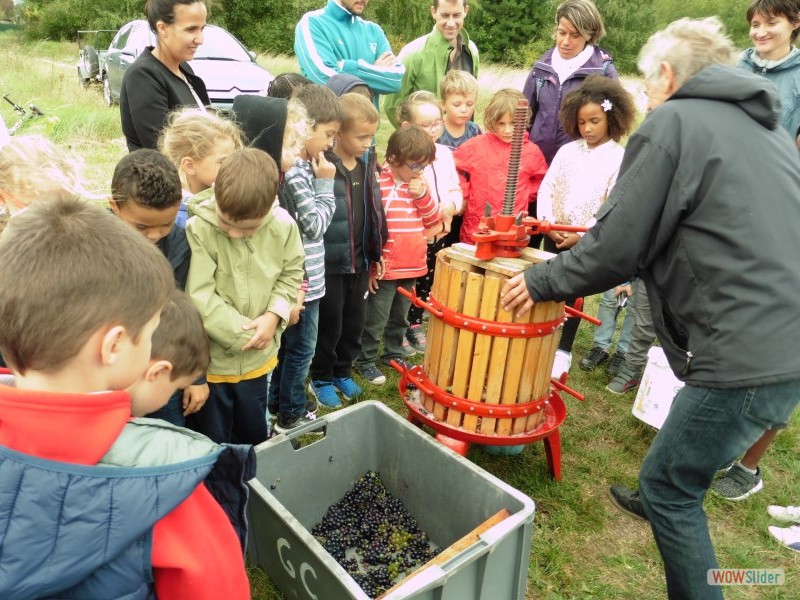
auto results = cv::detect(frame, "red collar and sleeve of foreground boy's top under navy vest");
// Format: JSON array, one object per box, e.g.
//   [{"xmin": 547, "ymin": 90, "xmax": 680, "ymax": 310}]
[{"xmin": 0, "ymin": 385, "xmax": 250, "ymax": 600}]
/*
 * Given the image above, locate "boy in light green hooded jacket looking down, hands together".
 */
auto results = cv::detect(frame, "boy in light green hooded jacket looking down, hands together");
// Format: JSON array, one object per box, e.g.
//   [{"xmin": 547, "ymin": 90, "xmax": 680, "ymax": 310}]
[{"xmin": 186, "ymin": 148, "xmax": 304, "ymax": 444}]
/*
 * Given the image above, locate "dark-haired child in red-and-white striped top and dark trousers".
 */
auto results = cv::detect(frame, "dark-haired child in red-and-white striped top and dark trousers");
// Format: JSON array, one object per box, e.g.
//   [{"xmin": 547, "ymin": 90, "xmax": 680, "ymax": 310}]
[{"xmin": 356, "ymin": 125, "xmax": 442, "ymax": 385}]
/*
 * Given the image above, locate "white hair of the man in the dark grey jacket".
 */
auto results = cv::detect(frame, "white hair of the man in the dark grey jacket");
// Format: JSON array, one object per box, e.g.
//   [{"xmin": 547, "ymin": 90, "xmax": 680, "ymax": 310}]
[{"xmin": 639, "ymin": 17, "xmax": 738, "ymax": 86}]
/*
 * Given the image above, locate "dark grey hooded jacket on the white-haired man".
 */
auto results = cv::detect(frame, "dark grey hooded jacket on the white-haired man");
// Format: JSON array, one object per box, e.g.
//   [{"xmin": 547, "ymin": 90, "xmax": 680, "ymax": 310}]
[{"xmin": 525, "ymin": 65, "xmax": 800, "ymax": 388}]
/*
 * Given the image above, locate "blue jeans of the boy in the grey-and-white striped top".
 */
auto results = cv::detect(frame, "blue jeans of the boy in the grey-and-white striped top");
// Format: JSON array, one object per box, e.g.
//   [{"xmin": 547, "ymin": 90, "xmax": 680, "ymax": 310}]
[{"xmin": 268, "ymin": 300, "xmax": 320, "ymax": 420}]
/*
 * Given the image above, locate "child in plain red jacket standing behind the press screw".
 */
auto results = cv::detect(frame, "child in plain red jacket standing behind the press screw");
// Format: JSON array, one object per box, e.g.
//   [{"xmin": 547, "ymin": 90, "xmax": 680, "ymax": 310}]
[{"xmin": 453, "ymin": 89, "xmax": 547, "ymax": 244}]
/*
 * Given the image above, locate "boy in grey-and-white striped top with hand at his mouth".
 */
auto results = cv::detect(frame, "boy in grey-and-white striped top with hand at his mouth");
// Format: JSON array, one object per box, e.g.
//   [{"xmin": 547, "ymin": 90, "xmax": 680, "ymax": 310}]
[{"xmin": 268, "ymin": 83, "xmax": 344, "ymax": 433}]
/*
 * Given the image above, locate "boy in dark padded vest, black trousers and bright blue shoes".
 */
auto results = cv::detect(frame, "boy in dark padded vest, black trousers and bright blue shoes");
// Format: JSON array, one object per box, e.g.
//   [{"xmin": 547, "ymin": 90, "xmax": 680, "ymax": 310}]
[{"xmin": 309, "ymin": 94, "xmax": 386, "ymax": 408}]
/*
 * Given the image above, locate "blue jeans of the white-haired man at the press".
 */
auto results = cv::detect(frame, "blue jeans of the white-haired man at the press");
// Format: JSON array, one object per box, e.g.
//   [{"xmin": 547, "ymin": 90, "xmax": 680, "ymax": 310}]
[{"xmin": 639, "ymin": 380, "xmax": 800, "ymax": 599}]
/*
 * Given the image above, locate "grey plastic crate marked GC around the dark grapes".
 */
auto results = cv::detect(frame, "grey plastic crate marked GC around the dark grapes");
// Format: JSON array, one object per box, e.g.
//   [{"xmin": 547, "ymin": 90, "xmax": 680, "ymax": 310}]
[{"xmin": 249, "ymin": 402, "xmax": 534, "ymax": 600}]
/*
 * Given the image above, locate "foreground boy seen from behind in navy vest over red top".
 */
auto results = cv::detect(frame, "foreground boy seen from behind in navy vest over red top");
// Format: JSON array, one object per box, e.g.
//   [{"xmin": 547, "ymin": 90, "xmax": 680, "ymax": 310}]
[{"xmin": 0, "ymin": 200, "xmax": 250, "ymax": 600}]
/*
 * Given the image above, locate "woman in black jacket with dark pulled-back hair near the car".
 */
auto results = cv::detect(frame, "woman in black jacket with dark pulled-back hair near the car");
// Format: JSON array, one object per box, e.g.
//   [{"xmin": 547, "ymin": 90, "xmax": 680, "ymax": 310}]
[{"xmin": 119, "ymin": 0, "xmax": 210, "ymax": 152}]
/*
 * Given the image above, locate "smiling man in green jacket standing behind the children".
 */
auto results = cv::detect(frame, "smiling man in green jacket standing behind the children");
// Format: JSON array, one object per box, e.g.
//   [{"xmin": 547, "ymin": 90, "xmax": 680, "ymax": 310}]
[{"xmin": 384, "ymin": 0, "xmax": 478, "ymax": 127}]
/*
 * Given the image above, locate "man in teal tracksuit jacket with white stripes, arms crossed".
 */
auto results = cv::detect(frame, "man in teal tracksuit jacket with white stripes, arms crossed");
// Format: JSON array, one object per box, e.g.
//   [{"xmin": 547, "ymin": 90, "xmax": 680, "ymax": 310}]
[{"xmin": 294, "ymin": 0, "xmax": 405, "ymax": 108}]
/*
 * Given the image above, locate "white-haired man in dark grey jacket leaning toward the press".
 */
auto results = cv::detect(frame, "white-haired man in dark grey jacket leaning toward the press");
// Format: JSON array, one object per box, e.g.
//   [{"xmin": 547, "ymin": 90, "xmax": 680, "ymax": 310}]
[{"xmin": 502, "ymin": 18, "xmax": 800, "ymax": 598}]
